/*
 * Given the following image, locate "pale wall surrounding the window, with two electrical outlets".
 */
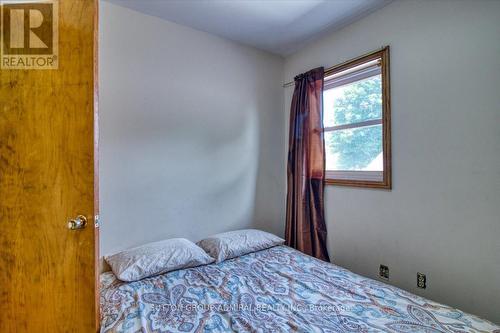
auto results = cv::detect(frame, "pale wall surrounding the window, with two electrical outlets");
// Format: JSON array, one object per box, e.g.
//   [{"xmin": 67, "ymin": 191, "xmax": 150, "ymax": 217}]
[{"xmin": 283, "ymin": 1, "xmax": 500, "ymax": 323}]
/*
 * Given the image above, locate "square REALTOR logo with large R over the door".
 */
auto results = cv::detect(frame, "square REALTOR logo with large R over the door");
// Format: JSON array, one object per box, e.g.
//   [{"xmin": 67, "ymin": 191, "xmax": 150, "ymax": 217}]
[{"xmin": 0, "ymin": 0, "xmax": 59, "ymax": 69}]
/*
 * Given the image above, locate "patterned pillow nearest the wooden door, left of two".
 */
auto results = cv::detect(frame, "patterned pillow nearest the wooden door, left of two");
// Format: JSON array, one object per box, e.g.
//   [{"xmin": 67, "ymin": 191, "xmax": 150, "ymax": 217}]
[{"xmin": 104, "ymin": 238, "xmax": 214, "ymax": 282}]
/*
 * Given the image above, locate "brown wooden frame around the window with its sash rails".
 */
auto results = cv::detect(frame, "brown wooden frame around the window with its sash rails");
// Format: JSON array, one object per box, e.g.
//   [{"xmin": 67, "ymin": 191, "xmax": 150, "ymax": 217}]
[{"xmin": 324, "ymin": 46, "xmax": 392, "ymax": 189}]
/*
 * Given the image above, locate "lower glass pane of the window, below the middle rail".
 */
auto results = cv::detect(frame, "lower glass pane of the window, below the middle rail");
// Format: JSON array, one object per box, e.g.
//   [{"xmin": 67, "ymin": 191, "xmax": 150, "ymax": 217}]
[{"xmin": 325, "ymin": 125, "xmax": 384, "ymax": 171}]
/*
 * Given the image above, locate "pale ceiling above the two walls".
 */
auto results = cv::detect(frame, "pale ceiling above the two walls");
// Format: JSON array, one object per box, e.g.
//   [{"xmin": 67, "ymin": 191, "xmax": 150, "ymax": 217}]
[{"xmin": 109, "ymin": 0, "xmax": 391, "ymax": 56}]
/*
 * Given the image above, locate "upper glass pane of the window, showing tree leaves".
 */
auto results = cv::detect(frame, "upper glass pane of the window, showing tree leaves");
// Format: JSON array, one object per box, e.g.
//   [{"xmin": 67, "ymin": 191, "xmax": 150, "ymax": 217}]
[{"xmin": 323, "ymin": 74, "xmax": 382, "ymax": 127}]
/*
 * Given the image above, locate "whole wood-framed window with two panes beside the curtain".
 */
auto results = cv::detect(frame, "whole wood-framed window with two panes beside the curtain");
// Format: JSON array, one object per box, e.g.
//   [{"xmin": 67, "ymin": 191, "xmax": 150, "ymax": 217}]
[{"xmin": 323, "ymin": 47, "xmax": 391, "ymax": 189}]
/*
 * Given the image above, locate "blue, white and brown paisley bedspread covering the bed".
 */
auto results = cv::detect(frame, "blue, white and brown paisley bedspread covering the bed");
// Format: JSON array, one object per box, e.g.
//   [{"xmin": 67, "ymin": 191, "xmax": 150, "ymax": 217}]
[{"xmin": 101, "ymin": 246, "xmax": 500, "ymax": 333}]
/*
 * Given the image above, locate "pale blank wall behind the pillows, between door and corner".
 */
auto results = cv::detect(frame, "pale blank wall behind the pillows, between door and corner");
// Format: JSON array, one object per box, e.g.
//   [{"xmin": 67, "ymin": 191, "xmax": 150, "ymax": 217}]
[{"xmin": 99, "ymin": 1, "xmax": 285, "ymax": 255}]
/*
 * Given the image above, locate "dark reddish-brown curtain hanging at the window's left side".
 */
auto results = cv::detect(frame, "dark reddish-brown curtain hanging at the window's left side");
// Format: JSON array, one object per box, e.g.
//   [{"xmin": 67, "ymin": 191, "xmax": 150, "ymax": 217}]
[{"xmin": 285, "ymin": 67, "xmax": 329, "ymax": 261}]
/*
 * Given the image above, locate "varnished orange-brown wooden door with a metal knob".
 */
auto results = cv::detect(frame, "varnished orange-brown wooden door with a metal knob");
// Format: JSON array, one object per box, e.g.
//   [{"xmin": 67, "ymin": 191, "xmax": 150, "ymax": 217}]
[{"xmin": 0, "ymin": 0, "xmax": 98, "ymax": 333}]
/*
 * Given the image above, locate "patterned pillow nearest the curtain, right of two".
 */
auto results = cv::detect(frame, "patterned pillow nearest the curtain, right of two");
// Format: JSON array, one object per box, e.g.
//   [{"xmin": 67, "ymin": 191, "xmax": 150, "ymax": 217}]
[{"xmin": 196, "ymin": 229, "xmax": 285, "ymax": 263}]
